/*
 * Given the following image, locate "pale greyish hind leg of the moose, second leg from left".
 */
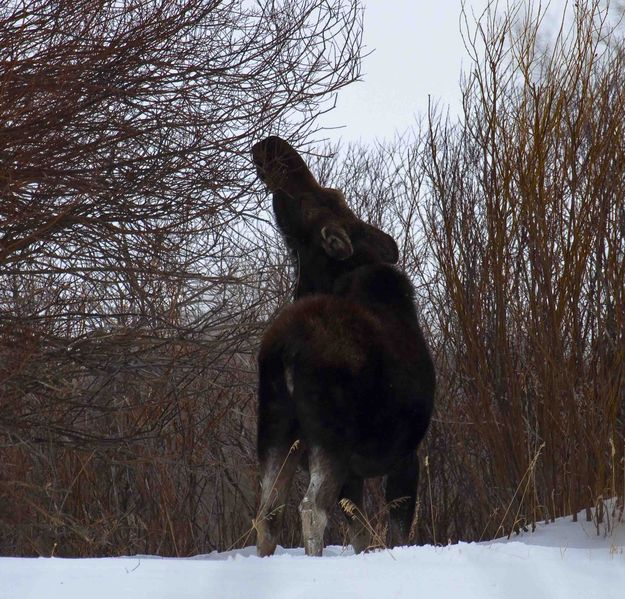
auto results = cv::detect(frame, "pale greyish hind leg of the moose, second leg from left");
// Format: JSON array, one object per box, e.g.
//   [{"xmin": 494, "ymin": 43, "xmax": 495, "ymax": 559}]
[{"xmin": 299, "ymin": 447, "xmax": 344, "ymax": 556}]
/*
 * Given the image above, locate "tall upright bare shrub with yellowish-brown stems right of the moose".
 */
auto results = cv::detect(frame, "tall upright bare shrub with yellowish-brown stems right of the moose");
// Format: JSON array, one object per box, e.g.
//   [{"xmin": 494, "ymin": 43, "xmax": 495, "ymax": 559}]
[{"xmin": 422, "ymin": 3, "xmax": 625, "ymax": 538}]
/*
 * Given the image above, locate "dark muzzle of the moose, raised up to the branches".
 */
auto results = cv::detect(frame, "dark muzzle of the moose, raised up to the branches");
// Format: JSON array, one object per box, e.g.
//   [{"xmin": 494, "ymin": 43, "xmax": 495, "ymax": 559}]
[{"xmin": 252, "ymin": 135, "xmax": 319, "ymax": 195}]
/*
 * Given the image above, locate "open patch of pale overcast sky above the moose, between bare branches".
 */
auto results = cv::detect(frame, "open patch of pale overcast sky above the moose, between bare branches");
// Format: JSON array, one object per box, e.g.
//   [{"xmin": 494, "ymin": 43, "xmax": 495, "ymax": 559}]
[{"xmin": 321, "ymin": 0, "xmax": 565, "ymax": 142}]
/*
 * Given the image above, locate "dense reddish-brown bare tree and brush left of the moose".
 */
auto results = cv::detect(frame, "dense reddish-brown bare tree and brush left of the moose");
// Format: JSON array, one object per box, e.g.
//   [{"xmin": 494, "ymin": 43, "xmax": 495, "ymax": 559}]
[{"xmin": 0, "ymin": 0, "xmax": 361, "ymax": 554}]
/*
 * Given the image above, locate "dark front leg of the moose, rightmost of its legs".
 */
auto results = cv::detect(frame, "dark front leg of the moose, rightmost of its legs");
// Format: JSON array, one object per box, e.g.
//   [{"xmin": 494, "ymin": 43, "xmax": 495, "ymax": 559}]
[{"xmin": 386, "ymin": 451, "xmax": 419, "ymax": 547}]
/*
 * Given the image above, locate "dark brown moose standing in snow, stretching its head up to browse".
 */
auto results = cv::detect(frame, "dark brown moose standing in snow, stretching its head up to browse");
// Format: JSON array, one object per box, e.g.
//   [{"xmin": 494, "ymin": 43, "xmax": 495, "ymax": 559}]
[{"xmin": 252, "ymin": 137, "xmax": 435, "ymax": 556}]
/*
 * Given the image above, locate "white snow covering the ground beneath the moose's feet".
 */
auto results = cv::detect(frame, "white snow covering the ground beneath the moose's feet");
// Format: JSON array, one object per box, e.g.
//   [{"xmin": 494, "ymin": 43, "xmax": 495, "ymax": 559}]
[{"xmin": 0, "ymin": 510, "xmax": 625, "ymax": 599}]
